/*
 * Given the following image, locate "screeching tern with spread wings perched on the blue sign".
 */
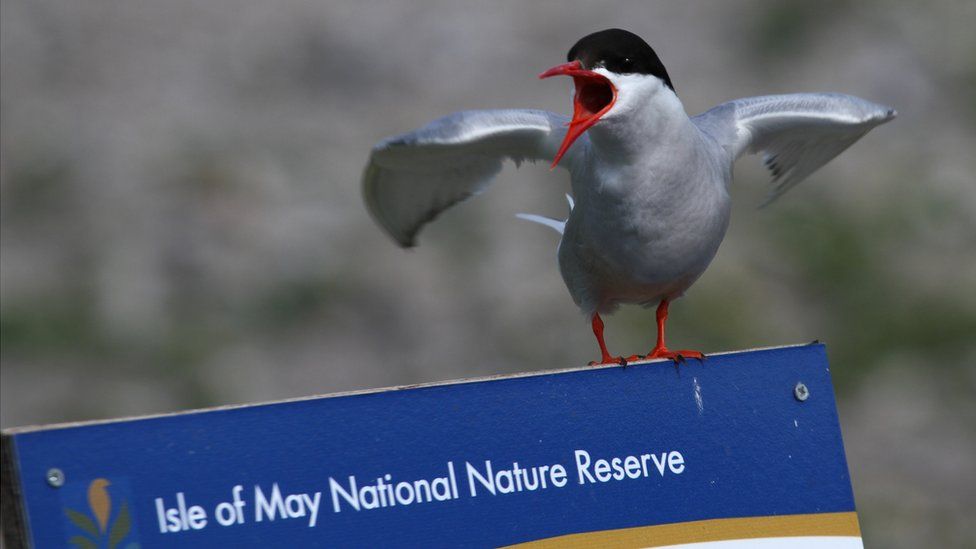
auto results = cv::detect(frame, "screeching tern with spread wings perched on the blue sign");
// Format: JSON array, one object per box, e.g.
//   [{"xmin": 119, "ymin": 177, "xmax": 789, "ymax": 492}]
[{"xmin": 362, "ymin": 28, "xmax": 897, "ymax": 365}]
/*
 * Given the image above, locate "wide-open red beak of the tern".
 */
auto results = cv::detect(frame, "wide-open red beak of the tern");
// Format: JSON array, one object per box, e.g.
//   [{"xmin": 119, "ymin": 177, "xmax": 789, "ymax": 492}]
[{"xmin": 539, "ymin": 61, "xmax": 617, "ymax": 168}]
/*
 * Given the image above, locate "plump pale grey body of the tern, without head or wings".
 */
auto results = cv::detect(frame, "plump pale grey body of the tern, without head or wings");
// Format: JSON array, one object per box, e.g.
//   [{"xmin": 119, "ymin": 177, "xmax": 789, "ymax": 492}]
[{"xmin": 558, "ymin": 83, "xmax": 731, "ymax": 317}]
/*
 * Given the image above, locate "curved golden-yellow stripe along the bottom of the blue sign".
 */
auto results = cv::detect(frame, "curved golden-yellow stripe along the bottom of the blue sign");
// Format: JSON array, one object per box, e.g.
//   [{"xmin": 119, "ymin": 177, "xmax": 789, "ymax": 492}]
[{"xmin": 509, "ymin": 511, "xmax": 861, "ymax": 549}]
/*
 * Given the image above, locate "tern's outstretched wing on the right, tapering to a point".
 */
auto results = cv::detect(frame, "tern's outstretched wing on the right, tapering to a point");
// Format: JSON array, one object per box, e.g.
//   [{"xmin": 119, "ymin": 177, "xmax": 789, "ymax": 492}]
[{"xmin": 692, "ymin": 93, "xmax": 896, "ymax": 205}]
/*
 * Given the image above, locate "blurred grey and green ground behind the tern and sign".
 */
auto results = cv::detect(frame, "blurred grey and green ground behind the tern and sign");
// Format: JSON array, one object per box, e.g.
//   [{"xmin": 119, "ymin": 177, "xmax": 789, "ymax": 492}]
[{"xmin": 0, "ymin": 0, "xmax": 976, "ymax": 547}]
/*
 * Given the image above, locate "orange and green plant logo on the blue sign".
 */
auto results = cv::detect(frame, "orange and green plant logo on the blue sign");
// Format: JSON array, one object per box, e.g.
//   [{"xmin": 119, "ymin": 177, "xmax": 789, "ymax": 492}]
[{"xmin": 62, "ymin": 478, "xmax": 140, "ymax": 549}]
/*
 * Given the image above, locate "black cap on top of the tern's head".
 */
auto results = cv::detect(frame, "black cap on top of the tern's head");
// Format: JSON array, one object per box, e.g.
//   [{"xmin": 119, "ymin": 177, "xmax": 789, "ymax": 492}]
[{"xmin": 566, "ymin": 29, "xmax": 674, "ymax": 91}]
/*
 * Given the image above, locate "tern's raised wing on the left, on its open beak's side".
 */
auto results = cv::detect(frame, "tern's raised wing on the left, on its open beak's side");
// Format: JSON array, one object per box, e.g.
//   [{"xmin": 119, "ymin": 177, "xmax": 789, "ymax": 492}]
[{"xmin": 363, "ymin": 110, "xmax": 583, "ymax": 247}]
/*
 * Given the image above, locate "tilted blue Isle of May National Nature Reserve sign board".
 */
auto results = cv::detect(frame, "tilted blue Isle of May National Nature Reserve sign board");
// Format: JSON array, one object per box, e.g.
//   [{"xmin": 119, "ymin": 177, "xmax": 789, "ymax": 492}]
[{"xmin": 3, "ymin": 344, "xmax": 861, "ymax": 549}]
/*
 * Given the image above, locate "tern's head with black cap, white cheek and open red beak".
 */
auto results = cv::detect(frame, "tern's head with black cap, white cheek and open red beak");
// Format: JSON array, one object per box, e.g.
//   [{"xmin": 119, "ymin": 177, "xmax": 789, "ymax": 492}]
[{"xmin": 539, "ymin": 29, "xmax": 674, "ymax": 166}]
